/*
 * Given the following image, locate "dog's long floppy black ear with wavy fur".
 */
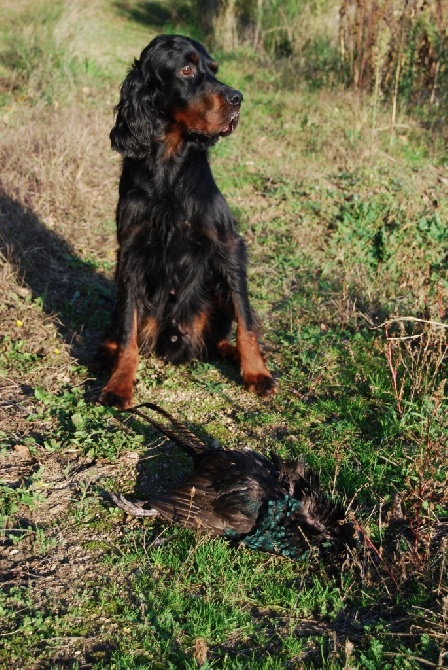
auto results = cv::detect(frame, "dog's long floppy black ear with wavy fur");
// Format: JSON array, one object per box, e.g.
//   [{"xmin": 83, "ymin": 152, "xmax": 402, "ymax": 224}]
[{"xmin": 109, "ymin": 60, "xmax": 155, "ymax": 159}]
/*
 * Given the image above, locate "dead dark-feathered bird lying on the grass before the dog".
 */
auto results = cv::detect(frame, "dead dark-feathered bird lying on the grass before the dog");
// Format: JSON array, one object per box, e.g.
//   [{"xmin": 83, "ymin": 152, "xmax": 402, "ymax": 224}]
[{"xmin": 110, "ymin": 402, "xmax": 355, "ymax": 559}]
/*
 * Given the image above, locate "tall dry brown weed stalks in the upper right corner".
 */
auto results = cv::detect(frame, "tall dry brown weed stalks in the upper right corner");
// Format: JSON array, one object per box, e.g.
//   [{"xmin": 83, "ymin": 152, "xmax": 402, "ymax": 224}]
[{"xmin": 339, "ymin": 0, "xmax": 448, "ymax": 125}]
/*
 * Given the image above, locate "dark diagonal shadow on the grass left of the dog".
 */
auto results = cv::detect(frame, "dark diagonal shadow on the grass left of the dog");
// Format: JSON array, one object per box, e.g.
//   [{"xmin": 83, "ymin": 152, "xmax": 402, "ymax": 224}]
[{"xmin": 0, "ymin": 188, "xmax": 114, "ymax": 370}]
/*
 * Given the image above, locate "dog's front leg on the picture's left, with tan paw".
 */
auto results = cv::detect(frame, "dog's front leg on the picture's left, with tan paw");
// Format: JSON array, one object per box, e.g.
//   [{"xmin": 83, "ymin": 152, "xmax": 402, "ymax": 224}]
[{"xmin": 99, "ymin": 282, "xmax": 138, "ymax": 409}]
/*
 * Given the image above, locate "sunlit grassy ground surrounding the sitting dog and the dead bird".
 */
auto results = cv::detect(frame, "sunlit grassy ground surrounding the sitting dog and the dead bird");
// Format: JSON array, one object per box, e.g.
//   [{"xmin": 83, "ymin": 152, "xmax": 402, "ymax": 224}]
[{"xmin": 0, "ymin": 0, "xmax": 448, "ymax": 670}]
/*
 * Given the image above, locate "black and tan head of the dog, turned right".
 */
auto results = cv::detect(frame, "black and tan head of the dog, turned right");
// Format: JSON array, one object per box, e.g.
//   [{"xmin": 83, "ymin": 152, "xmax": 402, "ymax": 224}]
[{"xmin": 110, "ymin": 35, "xmax": 243, "ymax": 159}]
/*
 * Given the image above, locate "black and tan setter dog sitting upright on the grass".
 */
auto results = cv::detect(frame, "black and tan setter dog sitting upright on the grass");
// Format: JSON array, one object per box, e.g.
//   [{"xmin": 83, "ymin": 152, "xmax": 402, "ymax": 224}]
[{"xmin": 100, "ymin": 35, "xmax": 275, "ymax": 408}]
